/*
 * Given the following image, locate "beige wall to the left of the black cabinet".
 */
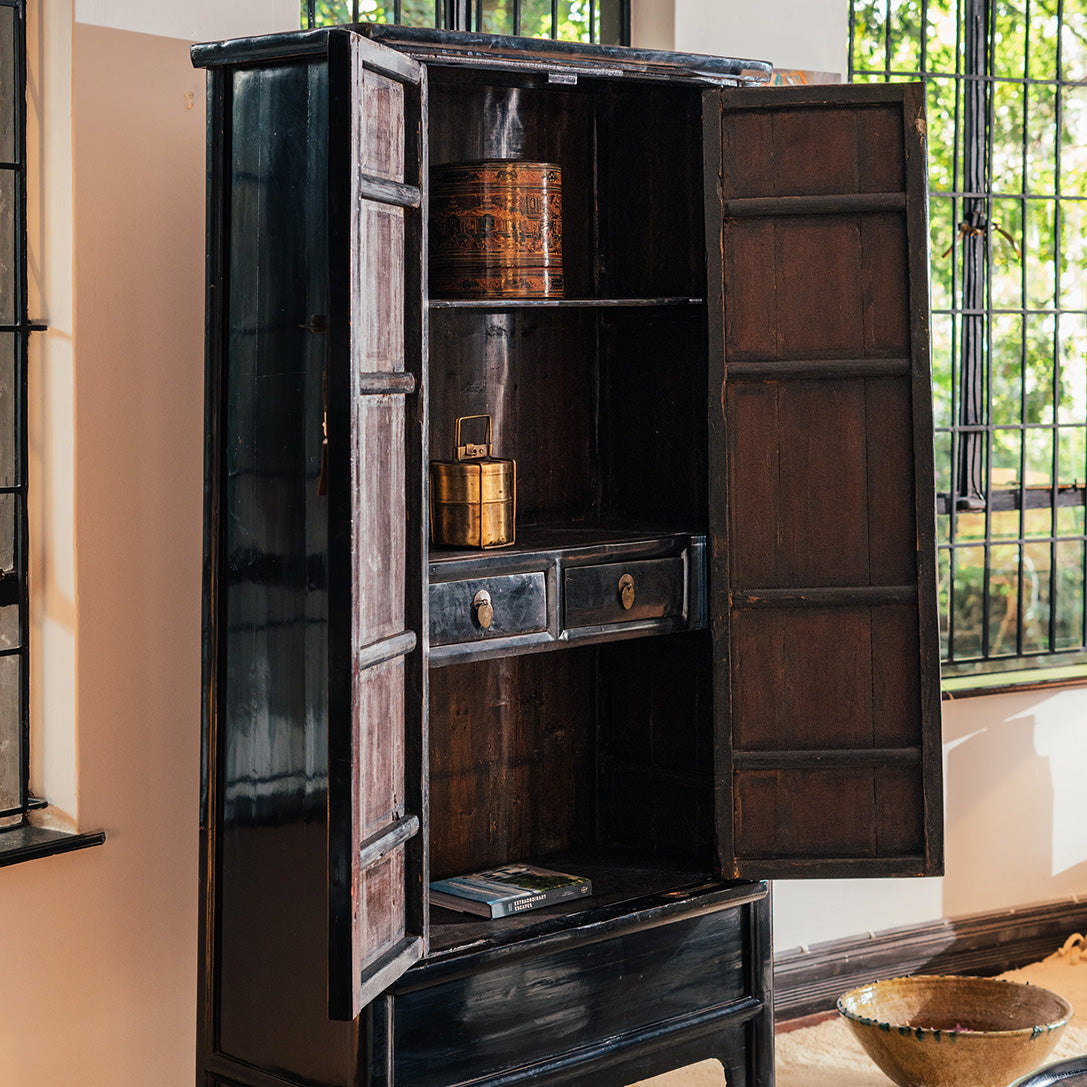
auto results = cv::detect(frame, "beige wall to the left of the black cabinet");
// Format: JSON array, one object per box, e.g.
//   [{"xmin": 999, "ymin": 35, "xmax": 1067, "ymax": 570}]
[{"xmin": 0, "ymin": 0, "xmax": 297, "ymax": 1087}]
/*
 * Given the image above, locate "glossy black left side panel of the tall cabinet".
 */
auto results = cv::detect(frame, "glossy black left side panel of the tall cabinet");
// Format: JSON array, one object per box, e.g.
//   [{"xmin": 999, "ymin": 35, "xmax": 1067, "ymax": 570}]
[{"xmin": 200, "ymin": 58, "xmax": 349, "ymax": 1084}]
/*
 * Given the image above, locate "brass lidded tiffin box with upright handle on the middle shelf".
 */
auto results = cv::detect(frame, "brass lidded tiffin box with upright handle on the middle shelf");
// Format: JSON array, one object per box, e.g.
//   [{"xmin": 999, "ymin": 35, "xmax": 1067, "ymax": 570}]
[{"xmin": 430, "ymin": 415, "xmax": 517, "ymax": 548}]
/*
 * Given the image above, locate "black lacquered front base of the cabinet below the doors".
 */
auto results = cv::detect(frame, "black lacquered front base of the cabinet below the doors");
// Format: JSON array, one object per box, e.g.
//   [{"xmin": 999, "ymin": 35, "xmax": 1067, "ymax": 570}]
[{"xmin": 371, "ymin": 885, "xmax": 773, "ymax": 1087}]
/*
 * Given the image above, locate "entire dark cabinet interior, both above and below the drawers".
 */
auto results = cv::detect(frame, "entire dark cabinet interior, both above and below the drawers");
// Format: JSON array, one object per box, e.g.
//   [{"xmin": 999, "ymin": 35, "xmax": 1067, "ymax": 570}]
[{"xmin": 428, "ymin": 68, "xmax": 713, "ymax": 948}]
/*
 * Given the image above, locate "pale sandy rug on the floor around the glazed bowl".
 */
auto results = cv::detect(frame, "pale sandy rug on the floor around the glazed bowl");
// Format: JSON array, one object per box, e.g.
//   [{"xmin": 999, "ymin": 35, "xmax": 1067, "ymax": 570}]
[{"xmin": 632, "ymin": 934, "xmax": 1087, "ymax": 1087}]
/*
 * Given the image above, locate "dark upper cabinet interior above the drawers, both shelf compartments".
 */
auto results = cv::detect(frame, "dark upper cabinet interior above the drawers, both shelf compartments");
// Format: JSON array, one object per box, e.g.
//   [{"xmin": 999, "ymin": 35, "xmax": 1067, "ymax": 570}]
[{"xmin": 429, "ymin": 76, "xmax": 705, "ymax": 530}]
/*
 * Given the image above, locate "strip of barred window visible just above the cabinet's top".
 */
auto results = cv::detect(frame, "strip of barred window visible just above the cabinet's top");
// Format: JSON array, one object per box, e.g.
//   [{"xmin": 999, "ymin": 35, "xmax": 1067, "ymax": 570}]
[{"xmin": 302, "ymin": 0, "xmax": 630, "ymax": 46}]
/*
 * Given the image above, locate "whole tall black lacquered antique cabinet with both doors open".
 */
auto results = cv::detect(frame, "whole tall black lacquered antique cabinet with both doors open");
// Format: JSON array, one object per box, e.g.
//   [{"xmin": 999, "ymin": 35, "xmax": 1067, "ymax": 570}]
[{"xmin": 193, "ymin": 27, "xmax": 941, "ymax": 1087}]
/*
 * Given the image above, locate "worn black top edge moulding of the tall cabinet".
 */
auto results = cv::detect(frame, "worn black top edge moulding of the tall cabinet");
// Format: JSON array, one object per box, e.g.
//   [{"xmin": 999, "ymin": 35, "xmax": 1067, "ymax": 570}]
[{"xmin": 191, "ymin": 23, "xmax": 773, "ymax": 86}]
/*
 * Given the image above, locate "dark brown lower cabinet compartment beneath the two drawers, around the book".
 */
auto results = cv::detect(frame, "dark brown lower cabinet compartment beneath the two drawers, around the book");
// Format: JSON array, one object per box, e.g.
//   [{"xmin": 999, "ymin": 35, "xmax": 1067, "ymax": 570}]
[{"xmin": 430, "ymin": 632, "xmax": 713, "ymax": 950}]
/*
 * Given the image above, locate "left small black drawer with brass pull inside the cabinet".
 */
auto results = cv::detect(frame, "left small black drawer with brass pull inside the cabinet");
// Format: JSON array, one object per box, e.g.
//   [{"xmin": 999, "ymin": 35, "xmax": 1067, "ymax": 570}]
[{"xmin": 430, "ymin": 571, "xmax": 547, "ymax": 646}]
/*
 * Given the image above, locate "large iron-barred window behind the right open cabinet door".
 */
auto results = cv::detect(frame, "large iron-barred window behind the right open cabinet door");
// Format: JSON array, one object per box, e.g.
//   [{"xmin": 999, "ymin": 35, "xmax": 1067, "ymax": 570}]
[{"xmin": 849, "ymin": 0, "xmax": 1087, "ymax": 678}]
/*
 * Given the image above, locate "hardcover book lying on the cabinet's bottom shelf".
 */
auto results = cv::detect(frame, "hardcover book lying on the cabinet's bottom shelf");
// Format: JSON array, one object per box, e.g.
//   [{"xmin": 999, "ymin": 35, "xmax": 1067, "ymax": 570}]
[{"xmin": 430, "ymin": 864, "xmax": 592, "ymax": 919}]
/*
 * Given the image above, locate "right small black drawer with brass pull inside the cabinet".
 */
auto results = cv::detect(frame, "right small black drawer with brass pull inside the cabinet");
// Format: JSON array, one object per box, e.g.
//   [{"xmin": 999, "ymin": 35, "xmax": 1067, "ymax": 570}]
[{"xmin": 563, "ymin": 555, "xmax": 687, "ymax": 628}]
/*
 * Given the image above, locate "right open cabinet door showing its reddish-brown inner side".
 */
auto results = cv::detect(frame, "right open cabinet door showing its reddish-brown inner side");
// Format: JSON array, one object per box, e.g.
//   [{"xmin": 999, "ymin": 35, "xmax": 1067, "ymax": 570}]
[{"xmin": 704, "ymin": 84, "xmax": 942, "ymax": 878}]
